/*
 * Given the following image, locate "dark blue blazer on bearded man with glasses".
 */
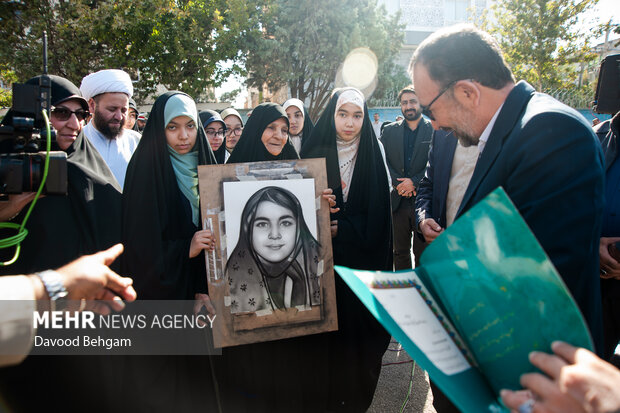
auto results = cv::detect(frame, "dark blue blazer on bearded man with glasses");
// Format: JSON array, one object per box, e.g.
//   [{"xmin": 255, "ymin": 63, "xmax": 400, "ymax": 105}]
[{"xmin": 457, "ymin": 81, "xmax": 605, "ymax": 352}]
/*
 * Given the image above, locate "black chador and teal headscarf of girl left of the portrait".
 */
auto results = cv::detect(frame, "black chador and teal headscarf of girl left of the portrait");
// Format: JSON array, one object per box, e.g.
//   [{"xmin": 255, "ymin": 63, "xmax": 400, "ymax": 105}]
[{"xmin": 116, "ymin": 92, "xmax": 217, "ymax": 412}]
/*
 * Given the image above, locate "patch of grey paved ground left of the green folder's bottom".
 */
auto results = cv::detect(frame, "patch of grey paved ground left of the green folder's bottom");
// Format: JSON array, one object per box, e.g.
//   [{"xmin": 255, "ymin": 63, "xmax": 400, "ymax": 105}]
[{"xmin": 368, "ymin": 339, "xmax": 435, "ymax": 413}]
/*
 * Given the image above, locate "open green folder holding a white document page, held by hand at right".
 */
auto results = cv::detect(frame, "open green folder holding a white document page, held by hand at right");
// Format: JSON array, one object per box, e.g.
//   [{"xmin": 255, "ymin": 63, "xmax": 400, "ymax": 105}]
[{"xmin": 335, "ymin": 188, "xmax": 593, "ymax": 413}]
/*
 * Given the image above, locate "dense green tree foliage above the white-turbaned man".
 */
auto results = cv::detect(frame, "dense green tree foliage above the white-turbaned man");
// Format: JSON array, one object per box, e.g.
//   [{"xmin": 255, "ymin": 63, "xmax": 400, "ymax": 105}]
[{"xmin": 0, "ymin": 0, "xmax": 262, "ymax": 100}]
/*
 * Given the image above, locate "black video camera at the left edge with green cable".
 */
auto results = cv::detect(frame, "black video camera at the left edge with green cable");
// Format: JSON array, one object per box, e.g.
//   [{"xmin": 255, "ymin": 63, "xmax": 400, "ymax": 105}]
[{"xmin": 0, "ymin": 31, "xmax": 67, "ymax": 195}]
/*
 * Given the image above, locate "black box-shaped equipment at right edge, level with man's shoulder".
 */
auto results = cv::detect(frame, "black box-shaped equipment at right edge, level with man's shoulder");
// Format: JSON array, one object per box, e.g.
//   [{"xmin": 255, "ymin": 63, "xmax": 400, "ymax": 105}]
[{"xmin": 592, "ymin": 54, "xmax": 620, "ymax": 115}]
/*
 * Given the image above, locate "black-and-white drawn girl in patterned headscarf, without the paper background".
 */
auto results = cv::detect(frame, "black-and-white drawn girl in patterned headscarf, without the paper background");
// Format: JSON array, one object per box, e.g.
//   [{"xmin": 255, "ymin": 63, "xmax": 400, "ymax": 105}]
[{"xmin": 226, "ymin": 186, "xmax": 321, "ymax": 314}]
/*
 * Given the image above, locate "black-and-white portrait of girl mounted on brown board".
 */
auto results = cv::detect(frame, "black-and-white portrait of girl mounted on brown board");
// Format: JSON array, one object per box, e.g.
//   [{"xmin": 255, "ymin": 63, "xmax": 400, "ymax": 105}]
[{"xmin": 198, "ymin": 159, "xmax": 338, "ymax": 347}]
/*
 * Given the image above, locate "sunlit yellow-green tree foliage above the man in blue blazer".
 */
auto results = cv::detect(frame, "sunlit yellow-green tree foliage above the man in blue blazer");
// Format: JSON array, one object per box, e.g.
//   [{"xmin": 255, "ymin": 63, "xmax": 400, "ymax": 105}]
[{"xmin": 484, "ymin": 0, "xmax": 598, "ymax": 90}]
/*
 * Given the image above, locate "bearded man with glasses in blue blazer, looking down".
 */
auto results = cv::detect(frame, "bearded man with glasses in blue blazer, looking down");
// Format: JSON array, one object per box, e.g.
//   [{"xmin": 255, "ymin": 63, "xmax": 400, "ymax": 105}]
[{"xmin": 410, "ymin": 25, "xmax": 604, "ymax": 352}]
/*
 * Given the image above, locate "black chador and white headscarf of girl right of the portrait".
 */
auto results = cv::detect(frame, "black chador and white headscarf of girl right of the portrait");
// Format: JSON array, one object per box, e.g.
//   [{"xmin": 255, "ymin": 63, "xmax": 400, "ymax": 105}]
[{"xmin": 301, "ymin": 88, "xmax": 392, "ymax": 411}]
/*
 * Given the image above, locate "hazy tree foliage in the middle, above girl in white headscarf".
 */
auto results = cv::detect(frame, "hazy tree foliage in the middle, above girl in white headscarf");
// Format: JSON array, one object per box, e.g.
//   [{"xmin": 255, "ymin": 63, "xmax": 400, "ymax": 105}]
[{"xmin": 246, "ymin": 0, "xmax": 403, "ymax": 117}]
